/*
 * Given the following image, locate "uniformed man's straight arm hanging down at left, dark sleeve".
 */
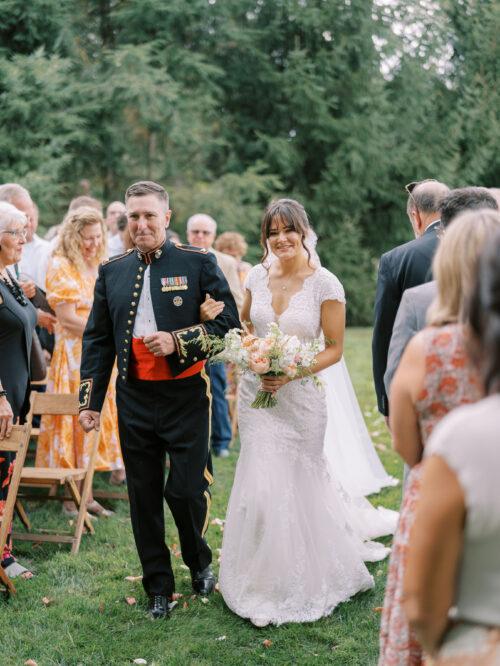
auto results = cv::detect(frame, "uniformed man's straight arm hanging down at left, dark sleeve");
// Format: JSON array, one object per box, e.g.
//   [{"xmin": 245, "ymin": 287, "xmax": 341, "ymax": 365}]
[{"xmin": 80, "ymin": 266, "xmax": 116, "ymax": 412}]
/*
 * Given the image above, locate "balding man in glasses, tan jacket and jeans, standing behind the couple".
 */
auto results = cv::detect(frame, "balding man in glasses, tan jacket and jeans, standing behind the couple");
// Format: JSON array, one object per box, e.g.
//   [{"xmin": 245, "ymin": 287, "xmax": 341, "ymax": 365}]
[{"xmin": 187, "ymin": 213, "xmax": 243, "ymax": 458}]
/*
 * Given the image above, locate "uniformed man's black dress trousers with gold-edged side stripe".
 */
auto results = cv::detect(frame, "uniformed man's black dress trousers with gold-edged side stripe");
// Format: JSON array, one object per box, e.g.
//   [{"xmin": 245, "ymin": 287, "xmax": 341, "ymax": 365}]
[{"xmin": 116, "ymin": 370, "xmax": 213, "ymax": 596}]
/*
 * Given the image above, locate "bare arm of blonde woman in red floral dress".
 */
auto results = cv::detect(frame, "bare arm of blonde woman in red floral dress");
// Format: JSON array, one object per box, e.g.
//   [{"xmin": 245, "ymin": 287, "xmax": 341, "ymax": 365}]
[{"xmin": 389, "ymin": 334, "xmax": 425, "ymax": 467}]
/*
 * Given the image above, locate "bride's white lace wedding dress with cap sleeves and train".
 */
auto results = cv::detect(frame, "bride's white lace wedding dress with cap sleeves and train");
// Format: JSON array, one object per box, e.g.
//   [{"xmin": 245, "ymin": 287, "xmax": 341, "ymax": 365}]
[{"xmin": 219, "ymin": 265, "xmax": 397, "ymax": 625}]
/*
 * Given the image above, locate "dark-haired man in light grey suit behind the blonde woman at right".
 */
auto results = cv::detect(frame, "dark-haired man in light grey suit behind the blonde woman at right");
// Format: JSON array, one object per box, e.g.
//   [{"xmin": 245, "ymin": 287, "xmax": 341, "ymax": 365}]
[{"xmin": 384, "ymin": 187, "xmax": 498, "ymax": 393}]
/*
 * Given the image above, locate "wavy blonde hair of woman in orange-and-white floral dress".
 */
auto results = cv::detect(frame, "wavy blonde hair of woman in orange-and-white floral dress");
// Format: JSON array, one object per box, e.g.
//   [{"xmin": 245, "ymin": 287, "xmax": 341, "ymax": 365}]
[{"xmin": 54, "ymin": 206, "xmax": 107, "ymax": 270}]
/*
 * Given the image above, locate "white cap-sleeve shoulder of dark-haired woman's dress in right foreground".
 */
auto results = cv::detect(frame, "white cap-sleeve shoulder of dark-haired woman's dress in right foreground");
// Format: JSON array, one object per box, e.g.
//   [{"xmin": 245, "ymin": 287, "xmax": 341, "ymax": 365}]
[{"xmin": 425, "ymin": 403, "xmax": 500, "ymax": 539}]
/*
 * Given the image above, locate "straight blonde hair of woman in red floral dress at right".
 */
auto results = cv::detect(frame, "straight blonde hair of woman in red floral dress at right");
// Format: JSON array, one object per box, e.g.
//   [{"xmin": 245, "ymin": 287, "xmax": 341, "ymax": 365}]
[{"xmin": 427, "ymin": 209, "xmax": 500, "ymax": 326}]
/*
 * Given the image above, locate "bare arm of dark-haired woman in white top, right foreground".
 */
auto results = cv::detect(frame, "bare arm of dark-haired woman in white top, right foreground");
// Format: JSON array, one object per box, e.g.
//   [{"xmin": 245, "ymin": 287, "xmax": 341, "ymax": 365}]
[{"xmin": 403, "ymin": 456, "xmax": 465, "ymax": 654}]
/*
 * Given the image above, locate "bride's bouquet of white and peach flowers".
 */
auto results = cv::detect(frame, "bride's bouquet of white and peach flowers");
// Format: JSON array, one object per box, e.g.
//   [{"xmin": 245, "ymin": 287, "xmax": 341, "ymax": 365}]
[{"xmin": 209, "ymin": 323, "xmax": 321, "ymax": 408}]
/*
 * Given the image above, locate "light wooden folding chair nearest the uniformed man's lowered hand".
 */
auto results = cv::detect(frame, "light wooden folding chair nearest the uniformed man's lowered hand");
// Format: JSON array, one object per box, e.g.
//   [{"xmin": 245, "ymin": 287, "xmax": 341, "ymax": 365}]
[{"xmin": 13, "ymin": 392, "xmax": 99, "ymax": 555}]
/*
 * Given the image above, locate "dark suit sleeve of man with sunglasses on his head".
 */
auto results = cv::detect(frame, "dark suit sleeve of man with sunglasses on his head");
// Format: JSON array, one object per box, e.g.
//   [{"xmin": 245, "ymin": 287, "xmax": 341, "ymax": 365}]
[{"xmin": 372, "ymin": 255, "xmax": 400, "ymax": 416}]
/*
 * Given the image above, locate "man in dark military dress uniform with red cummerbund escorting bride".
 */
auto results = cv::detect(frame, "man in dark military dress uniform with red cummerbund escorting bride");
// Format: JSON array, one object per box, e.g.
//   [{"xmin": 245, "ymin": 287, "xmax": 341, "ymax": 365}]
[{"xmin": 80, "ymin": 181, "xmax": 240, "ymax": 618}]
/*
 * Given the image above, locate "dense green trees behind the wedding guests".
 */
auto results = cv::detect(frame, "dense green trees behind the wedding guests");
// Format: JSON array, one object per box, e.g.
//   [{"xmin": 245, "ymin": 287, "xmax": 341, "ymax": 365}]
[{"xmin": 0, "ymin": 0, "xmax": 500, "ymax": 323}]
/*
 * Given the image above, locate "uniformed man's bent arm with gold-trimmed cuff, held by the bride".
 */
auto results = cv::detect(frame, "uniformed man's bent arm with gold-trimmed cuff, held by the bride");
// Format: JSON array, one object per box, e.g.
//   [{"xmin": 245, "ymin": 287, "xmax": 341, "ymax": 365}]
[{"xmin": 169, "ymin": 253, "xmax": 241, "ymax": 374}]
